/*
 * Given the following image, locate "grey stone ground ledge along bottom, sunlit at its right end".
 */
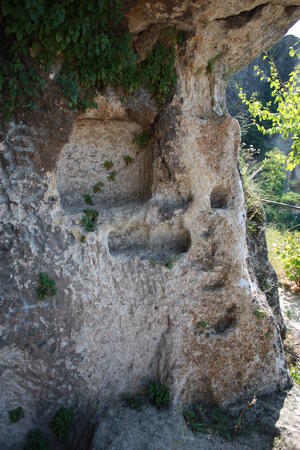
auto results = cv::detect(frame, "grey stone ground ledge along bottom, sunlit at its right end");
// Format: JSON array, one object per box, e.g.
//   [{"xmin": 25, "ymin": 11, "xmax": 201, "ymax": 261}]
[{"xmin": 91, "ymin": 388, "xmax": 300, "ymax": 450}]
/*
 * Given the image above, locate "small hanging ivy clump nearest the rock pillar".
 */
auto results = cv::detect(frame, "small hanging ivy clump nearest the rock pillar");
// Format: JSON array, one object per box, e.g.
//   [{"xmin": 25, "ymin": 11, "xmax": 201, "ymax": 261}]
[{"xmin": 142, "ymin": 42, "xmax": 177, "ymax": 105}]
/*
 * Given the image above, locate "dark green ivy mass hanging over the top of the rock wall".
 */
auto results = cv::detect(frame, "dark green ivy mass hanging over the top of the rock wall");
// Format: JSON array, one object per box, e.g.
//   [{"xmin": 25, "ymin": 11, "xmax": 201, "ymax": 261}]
[{"xmin": 0, "ymin": 0, "xmax": 180, "ymax": 117}]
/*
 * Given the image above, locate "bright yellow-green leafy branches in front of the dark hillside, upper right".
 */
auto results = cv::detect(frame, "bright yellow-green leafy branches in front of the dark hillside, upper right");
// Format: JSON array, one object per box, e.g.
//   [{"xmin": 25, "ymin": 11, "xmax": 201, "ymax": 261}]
[{"xmin": 239, "ymin": 49, "xmax": 300, "ymax": 170}]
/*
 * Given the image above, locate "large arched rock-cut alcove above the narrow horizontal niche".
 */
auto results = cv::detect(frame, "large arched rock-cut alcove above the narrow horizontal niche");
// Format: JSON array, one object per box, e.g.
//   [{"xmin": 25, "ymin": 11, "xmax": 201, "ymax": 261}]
[{"xmin": 56, "ymin": 104, "xmax": 153, "ymax": 210}]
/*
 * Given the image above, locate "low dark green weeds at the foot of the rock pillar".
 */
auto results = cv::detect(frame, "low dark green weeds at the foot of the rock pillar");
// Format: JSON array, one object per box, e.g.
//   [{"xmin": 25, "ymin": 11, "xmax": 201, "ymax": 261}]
[{"xmin": 183, "ymin": 405, "xmax": 235, "ymax": 440}]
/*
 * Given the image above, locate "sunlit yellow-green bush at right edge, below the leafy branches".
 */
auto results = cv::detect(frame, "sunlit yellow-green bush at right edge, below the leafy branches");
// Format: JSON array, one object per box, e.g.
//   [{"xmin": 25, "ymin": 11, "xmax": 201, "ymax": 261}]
[{"xmin": 276, "ymin": 231, "xmax": 300, "ymax": 287}]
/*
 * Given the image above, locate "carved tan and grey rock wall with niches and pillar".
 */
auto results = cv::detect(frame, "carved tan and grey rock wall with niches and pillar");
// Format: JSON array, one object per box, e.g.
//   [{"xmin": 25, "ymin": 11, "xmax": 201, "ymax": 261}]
[{"xmin": 0, "ymin": 0, "xmax": 300, "ymax": 449}]
